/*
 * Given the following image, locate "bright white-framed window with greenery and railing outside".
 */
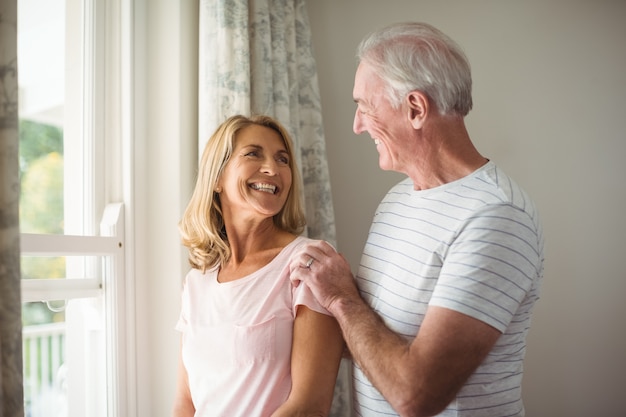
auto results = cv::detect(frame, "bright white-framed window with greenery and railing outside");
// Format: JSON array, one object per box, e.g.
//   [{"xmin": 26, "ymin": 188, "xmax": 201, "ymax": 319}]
[{"xmin": 18, "ymin": 0, "xmax": 134, "ymax": 417}]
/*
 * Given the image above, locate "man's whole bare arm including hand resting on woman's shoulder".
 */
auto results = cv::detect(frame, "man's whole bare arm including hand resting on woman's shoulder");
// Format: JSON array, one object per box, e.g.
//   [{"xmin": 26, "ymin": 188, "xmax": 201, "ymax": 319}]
[{"xmin": 291, "ymin": 243, "xmax": 500, "ymax": 416}]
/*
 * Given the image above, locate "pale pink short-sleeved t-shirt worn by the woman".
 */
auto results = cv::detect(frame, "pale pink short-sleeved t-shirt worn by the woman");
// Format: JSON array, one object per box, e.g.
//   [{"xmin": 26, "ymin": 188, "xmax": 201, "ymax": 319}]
[{"xmin": 176, "ymin": 237, "xmax": 329, "ymax": 417}]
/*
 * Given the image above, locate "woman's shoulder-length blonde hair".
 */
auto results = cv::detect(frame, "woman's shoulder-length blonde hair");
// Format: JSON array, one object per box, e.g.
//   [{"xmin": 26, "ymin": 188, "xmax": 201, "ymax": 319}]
[{"xmin": 178, "ymin": 115, "xmax": 305, "ymax": 271}]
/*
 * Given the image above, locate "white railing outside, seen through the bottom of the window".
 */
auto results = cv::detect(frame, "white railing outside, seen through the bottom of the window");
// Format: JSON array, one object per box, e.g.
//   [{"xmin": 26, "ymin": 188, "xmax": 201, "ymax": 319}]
[{"xmin": 22, "ymin": 323, "xmax": 67, "ymax": 417}]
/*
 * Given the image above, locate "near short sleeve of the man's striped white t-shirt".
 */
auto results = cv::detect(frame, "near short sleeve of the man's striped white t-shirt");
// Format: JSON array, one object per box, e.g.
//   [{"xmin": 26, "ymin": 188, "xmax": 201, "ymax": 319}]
[{"xmin": 430, "ymin": 205, "xmax": 540, "ymax": 331}]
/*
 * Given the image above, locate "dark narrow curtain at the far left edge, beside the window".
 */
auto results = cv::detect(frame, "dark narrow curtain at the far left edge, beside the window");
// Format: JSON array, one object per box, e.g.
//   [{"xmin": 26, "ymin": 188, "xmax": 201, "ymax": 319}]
[{"xmin": 0, "ymin": 0, "xmax": 24, "ymax": 417}]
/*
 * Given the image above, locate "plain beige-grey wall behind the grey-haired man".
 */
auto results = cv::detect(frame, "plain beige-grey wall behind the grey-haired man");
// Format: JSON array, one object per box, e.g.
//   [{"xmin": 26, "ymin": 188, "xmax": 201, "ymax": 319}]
[{"xmin": 308, "ymin": 0, "xmax": 626, "ymax": 417}]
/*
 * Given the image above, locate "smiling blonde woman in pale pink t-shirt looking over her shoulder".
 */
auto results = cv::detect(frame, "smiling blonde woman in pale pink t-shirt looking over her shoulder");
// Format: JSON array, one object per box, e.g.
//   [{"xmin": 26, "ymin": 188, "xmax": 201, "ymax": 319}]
[{"xmin": 173, "ymin": 116, "xmax": 343, "ymax": 417}]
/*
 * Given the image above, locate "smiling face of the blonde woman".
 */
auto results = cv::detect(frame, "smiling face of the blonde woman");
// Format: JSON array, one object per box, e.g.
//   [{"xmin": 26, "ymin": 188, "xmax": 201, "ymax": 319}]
[{"xmin": 218, "ymin": 125, "xmax": 292, "ymax": 218}]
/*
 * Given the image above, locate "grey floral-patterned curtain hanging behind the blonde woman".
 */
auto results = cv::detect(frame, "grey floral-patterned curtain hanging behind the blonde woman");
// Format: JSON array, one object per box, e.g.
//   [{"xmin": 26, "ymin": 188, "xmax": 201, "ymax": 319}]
[{"xmin": 198, "ymin": 0, "xmax": 351, "ymax": 417}]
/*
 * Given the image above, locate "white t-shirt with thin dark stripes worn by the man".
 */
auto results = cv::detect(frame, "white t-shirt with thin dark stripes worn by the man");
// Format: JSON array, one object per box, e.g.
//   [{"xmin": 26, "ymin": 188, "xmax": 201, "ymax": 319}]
[{"xmin": 354, "ymin": 162, "xmax": 543, "ymax": 417}]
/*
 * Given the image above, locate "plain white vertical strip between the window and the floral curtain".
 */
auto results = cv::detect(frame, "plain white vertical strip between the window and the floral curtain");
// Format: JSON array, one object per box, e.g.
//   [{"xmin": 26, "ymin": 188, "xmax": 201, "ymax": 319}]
[{"xmin": 133, "ymin": 0, "xmax": 198, "ymax": 417}]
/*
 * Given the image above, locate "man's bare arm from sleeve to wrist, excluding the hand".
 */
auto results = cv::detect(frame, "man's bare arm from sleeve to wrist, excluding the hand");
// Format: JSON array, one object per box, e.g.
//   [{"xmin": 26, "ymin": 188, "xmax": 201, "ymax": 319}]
[{"xmin": 332, "ymin": 294, "xmax": 500, "ymax": 416}]
